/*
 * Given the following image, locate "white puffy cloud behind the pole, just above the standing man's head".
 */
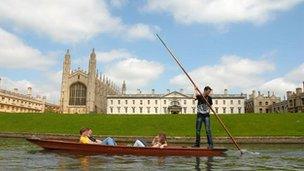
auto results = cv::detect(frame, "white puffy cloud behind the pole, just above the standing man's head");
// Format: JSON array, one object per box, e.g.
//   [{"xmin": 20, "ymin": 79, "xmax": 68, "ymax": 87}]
[{"xmin": 170, "ymin": 55, "xmax": 275, "ymax": 93}]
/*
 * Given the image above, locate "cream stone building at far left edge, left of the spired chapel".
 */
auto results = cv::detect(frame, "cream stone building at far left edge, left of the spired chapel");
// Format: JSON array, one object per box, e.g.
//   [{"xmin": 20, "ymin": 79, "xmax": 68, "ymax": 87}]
[{"xmin": 0, "ymin": 87, "xmax": 45, "ymax": 113}]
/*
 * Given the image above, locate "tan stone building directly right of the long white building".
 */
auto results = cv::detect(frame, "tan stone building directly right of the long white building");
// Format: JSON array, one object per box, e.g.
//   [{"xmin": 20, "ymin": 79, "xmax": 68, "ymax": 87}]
[{"xmin": 245, "ymin": 90, "xmax": 281, "ymax": 113}]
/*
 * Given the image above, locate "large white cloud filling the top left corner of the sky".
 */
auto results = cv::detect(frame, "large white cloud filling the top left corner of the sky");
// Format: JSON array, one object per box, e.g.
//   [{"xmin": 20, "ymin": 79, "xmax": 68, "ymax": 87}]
[{"xmin": 0, "ymin": 0, "xmax": 154, "ymax": 43}]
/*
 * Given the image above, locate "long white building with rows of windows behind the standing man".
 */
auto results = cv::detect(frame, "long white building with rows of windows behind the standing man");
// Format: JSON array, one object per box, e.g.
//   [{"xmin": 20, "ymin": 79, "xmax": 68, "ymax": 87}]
[{"xmin": 107, "ymin": 87, "xmax": 246, "ymax": 114}]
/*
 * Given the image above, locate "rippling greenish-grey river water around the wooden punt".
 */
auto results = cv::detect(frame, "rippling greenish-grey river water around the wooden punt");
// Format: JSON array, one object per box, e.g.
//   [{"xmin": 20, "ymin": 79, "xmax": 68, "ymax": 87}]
[{"xmin": 0, "ymin": 138, "xmax": 304, "ymax": 171}]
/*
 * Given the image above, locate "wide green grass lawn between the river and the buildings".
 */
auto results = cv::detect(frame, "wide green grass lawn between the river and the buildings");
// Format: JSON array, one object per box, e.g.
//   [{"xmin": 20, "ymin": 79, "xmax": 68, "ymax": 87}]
[{"xmin": 0, "ymin": 113, "xmax": 304, "ymax": 136}]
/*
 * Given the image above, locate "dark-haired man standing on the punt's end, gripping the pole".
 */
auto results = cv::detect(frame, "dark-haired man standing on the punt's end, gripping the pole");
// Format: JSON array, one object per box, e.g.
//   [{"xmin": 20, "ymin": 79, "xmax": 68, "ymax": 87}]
[{"xmin": 193, "ymin": 86, "xmax": 213, "ymax": 149}]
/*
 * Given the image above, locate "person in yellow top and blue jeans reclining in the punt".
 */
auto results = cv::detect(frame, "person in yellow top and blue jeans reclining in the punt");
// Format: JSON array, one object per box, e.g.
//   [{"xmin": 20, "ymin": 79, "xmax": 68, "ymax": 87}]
[{"xmin": 79, "ymin": 128, "xmax": 117, "ymax": 146}]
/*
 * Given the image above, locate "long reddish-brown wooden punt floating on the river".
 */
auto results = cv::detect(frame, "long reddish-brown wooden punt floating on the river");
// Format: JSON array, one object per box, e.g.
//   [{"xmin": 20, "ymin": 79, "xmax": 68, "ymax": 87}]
[{"xmin": 27, "ymin": 138, "xmax": 227, "ymax": 156}]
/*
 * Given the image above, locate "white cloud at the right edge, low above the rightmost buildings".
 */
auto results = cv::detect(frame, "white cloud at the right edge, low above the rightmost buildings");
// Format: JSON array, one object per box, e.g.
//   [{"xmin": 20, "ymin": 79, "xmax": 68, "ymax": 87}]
[{"xmin": 260, "ymin": 63, "xmax": 304, "ymax": 97}]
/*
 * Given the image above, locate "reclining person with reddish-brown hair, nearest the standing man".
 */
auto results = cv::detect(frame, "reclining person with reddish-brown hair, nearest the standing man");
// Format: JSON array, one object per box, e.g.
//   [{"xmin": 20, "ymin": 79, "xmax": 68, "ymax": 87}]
[{"xmin": 133, "ymin": 133, "xmax": 168, "ymax": 148}]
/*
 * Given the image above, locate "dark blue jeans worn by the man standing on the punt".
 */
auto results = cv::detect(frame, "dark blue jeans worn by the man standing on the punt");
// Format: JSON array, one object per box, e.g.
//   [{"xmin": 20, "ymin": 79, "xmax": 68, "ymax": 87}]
[{"xmin": 195, "ymin": 113, "xmax": 213, "ymax": 148}]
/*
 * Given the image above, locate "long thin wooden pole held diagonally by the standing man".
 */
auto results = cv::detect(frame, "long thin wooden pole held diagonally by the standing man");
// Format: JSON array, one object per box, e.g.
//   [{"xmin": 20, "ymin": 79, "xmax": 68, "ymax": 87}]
[{"xmin": 156, "ymin": 34, "xmax": 243, "ymax": 153}]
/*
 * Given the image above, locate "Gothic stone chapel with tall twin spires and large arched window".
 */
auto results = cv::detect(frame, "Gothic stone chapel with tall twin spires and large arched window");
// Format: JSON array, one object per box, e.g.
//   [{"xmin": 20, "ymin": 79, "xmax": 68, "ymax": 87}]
[{"xmin": 60, "ymin": 49, "xmax": 119, "ymax": 113}]
